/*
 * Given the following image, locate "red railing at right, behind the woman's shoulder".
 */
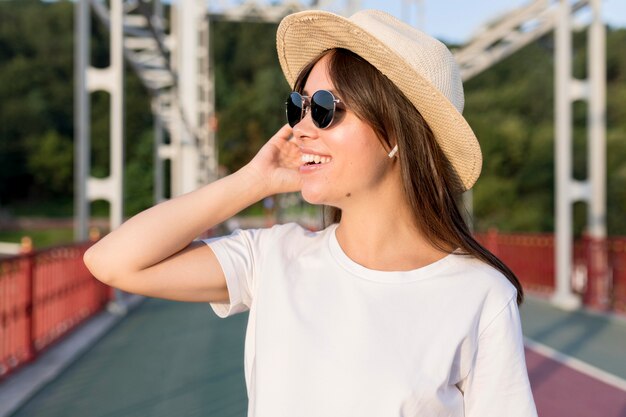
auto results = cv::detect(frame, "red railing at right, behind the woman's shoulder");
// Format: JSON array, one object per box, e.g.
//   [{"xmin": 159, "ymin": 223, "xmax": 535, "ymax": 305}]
[{"xmin": 475, "ymin": 230, "xmax": 626, "ymax": 313}]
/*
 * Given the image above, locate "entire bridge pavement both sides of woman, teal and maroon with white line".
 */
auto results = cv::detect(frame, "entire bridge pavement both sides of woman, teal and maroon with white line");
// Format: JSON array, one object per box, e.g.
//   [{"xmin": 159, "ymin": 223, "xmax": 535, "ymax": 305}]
[{"xmin": 0, "ymin": 296, "xmax": 626, "ymax": 417}]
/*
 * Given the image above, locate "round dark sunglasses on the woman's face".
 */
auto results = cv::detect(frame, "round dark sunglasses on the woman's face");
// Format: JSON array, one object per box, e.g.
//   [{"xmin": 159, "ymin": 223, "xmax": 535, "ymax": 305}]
[{"xmin": 285, "ymin": 90, "xmax": 341, "ymax": 129}]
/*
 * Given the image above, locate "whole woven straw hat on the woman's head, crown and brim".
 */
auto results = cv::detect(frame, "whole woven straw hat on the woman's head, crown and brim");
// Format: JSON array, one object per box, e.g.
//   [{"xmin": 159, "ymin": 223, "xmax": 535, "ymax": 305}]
[{"xmin": 276, "ymin": 10, "xmax": 482, "ymax": 191}]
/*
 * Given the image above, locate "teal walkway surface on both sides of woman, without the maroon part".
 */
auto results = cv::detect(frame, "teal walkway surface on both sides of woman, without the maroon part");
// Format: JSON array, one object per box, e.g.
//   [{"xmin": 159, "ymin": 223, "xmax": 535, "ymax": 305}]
[{"xmin": 4, "ymin": 297, "xmax": 626, "ymax": 417}]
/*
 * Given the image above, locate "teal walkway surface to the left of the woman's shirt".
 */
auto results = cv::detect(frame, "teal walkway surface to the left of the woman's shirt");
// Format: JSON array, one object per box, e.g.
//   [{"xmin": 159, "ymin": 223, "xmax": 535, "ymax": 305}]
[{"xmin": 13, "ymin": 299, "xmax": 248, "ymax": 417}]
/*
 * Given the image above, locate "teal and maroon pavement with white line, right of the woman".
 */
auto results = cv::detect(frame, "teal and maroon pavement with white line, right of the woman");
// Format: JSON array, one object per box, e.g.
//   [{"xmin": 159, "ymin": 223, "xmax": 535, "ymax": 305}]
[{"xmin": 520, "ymin": 297, "xmax": 626, "ymax": 417}]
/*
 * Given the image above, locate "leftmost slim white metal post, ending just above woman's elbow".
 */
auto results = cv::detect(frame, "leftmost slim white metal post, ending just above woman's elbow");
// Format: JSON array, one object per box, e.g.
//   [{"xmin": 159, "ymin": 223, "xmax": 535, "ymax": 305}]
[{"xmin": 74, "ymin": 0, "xmax": 91, "ymax": 241}]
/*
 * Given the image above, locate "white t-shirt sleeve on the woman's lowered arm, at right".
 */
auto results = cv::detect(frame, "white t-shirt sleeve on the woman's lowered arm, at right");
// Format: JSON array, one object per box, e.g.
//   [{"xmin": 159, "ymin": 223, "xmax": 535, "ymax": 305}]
[{"xmin": 459, "ymin": 297, "xmax": 537, "ymax": 417}]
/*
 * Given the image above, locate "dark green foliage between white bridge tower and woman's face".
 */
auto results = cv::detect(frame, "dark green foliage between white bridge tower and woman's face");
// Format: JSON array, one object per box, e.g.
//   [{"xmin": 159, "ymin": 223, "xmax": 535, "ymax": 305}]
[{"xmin": 211, "ymin": 21, "xmax": 290, "ymax": 170}]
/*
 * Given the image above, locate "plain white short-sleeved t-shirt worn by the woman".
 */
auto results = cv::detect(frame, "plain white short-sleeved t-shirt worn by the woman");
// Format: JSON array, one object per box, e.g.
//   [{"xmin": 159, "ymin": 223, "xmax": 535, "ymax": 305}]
[{"xmin": 206, "ymin": 224, "xmax": 537, "ymax": 417}]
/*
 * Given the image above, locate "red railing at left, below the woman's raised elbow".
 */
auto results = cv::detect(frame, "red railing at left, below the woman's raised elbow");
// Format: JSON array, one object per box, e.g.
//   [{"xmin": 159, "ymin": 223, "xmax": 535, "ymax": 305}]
[{"xmin": 0, "ymin": 243, "xmax": 113, "ymax": 379}]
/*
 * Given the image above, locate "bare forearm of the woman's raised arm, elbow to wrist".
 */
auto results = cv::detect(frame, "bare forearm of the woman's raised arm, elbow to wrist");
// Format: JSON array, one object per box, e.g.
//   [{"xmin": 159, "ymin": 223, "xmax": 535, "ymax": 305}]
[{"xmin": 85, "ymin": 164, "xmax": 267, "ymax": 281}]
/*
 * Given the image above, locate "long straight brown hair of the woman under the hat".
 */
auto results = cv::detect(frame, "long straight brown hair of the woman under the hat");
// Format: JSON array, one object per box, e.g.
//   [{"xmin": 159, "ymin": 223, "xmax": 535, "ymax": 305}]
[{"xmin": 294, "ymin": 48, "xmax": 524, "ymax": 305}]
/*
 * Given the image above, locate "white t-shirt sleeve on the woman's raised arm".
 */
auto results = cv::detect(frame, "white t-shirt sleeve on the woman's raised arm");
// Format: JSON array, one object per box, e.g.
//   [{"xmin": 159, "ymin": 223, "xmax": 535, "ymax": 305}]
[{"xmin": 203, "ymin": 229, "xmax": 262, "ymax": 318}]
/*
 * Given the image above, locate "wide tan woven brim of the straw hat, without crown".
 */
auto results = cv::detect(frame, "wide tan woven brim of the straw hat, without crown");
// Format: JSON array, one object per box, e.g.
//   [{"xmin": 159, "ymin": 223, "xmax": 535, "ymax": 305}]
[{"xmin": 276, "ymin": 11, "xmax": 482, "ymax": 191}]
